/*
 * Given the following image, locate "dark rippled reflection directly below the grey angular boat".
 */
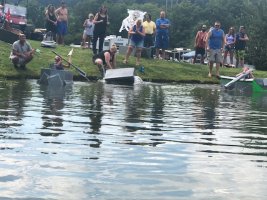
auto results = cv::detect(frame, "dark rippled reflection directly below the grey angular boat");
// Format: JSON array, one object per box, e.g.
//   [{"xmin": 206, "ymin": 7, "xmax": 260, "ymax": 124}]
[{"xmin": 40, "ymin": 86, "xmax": 68, "ymax": 136}]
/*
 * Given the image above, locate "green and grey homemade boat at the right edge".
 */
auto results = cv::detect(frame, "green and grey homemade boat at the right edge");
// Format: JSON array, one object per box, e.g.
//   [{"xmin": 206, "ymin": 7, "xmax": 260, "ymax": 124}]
[{"xmin": 220, "ymin": 76, "xmax": 267, "ymax": 94}]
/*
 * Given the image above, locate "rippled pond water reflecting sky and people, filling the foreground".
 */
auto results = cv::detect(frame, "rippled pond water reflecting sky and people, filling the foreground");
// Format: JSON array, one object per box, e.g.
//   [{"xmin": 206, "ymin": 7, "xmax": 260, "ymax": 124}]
[{"xmin": 0, "ymin": 80, "xmax": 267, "ymax": 200}]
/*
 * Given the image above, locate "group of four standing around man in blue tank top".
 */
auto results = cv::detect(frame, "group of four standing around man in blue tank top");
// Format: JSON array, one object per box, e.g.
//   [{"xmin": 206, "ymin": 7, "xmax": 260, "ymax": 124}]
[{"xmin": 196, "ymin": 21, "xmax": 249, "ymax": 77}]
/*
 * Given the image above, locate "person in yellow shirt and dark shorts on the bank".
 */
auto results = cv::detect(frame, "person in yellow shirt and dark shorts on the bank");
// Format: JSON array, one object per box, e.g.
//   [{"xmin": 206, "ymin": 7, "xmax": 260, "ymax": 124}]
[{"xmin": 143, "ymin": 14, "xmax": 156, "ymax": 48}]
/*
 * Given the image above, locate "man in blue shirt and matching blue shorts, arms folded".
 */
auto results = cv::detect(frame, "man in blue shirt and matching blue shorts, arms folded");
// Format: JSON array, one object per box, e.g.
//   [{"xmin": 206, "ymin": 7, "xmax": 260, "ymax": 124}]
[{"xmin": 155, "ymin": 11, "xmax": 170, "ymax": 59}]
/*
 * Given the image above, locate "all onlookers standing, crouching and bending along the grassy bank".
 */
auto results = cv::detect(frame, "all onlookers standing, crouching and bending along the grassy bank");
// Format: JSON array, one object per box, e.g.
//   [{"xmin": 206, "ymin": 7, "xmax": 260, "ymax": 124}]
[{"xmin": 9, "ymin": 1, "xmax": 249, "ymax": 77}]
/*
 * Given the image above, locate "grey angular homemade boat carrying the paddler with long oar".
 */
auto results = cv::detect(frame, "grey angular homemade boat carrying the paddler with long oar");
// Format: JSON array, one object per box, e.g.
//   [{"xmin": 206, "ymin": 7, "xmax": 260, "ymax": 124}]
[{"xmin": 38, "ymin": 68, "xmax": 73, "ymax": 86}]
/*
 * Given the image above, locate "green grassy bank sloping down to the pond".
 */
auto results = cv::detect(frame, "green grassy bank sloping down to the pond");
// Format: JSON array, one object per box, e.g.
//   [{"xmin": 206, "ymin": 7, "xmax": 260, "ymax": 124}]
[{"xmin": 0, "ymin": 41, "xmax": 267, "ymax": 83}]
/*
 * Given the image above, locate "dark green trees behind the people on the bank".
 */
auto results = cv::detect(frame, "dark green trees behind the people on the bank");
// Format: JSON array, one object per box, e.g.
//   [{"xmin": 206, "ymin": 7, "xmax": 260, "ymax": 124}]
[{"xmin": 22, "ymin": 0, "xmax": 267, "ymax": 70}]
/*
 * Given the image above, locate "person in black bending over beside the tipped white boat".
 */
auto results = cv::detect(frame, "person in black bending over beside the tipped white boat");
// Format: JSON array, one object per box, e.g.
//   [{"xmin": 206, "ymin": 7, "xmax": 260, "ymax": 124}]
[{"xmin": 93, "ymin": 44, "xmax": 117, "ymax": 76}]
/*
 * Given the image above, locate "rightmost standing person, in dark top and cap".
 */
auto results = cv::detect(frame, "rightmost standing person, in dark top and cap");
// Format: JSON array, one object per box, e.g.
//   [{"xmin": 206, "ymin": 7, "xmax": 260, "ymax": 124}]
[{"xmin": 235, "ymin": 26, "xmax": 249, "ymax": 68}]
